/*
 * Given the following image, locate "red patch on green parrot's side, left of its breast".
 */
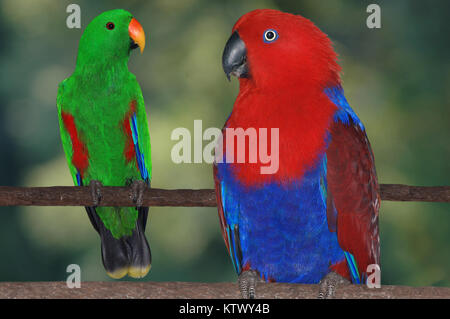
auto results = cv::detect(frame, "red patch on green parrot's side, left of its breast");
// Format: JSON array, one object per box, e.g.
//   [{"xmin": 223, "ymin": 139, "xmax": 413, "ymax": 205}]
[{"xmin": 61, "ymin": 112, "xmax": 89, "ymax": 176}]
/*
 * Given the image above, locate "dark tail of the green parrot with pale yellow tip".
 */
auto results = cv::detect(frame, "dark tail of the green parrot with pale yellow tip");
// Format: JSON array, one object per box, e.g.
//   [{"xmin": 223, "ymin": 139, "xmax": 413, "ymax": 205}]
[{"xmin": 86, "ymin": 207, "xmax": 152, "ymax": 279}]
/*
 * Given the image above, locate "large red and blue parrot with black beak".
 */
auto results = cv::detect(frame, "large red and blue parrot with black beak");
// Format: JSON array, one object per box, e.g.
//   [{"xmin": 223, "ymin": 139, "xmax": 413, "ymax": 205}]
[{"xmin": 214, "ymin": 10, "xmax": 380, "ymax": 298}]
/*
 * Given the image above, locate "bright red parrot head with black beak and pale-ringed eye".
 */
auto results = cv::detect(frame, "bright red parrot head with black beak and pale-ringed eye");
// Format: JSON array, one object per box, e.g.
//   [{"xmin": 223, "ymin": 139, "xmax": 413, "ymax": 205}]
[{"xmin": 222, "ymin": 9, "xmax": 340, "ymax": 89}]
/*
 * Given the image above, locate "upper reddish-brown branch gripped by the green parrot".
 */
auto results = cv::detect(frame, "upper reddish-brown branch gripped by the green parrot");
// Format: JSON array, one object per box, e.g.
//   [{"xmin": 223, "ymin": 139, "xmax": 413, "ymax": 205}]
[{"xmin": 0, "ymin": 184, "xmax": 450, "ymax": 207}]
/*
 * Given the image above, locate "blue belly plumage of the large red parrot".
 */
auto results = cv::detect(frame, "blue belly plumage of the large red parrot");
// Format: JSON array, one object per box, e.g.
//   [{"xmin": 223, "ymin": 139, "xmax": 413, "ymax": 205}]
[{"xmin": 217, "ymin": 154, "xmax": 345, "ymax": 283}]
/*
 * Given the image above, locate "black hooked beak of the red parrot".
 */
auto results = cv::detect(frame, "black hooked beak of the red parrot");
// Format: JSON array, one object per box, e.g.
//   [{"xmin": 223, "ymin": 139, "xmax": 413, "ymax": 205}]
[{"xmin": 222, "ymin": 31, "xmax": 249, "ymax": 80}]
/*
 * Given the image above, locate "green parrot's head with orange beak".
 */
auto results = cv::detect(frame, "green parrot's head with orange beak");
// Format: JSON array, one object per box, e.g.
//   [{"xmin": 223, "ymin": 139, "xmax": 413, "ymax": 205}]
[{"xmin": 77, "ymin": 9, "xmax": 145, "ymax": 65}]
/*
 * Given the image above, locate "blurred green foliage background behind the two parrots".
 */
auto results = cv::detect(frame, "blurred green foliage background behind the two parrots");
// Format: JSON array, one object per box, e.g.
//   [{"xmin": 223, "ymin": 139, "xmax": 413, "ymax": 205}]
[{"xmin": 0, "ymin": 0, "xmax": 450, "ymax": 286}]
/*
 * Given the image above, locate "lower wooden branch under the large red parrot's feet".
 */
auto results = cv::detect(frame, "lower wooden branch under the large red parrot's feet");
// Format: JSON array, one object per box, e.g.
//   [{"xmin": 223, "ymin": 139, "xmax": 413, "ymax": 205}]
[{"xmin": 0, "ymin": 281, "xmax": 450, "ymax": 299}]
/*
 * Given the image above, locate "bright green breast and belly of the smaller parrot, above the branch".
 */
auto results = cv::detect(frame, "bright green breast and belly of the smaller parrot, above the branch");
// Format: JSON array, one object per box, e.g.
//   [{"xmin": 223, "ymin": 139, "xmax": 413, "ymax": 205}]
[{"xmin": 63, "ymin": 72, "xmax": 140, "ymax": 186}]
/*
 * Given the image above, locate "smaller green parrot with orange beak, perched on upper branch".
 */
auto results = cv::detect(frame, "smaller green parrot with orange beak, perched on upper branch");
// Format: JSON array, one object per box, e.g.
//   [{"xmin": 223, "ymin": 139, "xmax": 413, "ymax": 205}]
[{"xmin": 57, "ymin": 10, "xmax": 151, "ymax": 279}]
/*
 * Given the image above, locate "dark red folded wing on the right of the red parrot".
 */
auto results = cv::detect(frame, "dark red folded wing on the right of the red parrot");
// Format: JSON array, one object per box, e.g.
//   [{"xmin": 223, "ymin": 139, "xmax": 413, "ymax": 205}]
[{"xmin": 327, "ymin": 119, "xmax": 380, "ymax": 281}]
